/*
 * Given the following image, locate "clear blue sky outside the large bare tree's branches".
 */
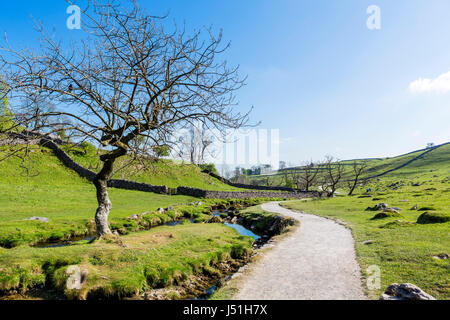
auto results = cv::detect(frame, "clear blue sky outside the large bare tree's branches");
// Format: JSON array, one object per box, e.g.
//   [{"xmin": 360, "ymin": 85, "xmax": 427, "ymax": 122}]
[{"xmin": 0, "ymin": 0, "xmax": 450, "ymax": 164}]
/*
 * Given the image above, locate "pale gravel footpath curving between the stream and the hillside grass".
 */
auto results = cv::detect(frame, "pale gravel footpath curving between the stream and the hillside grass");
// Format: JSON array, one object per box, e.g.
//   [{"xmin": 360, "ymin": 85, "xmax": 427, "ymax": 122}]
[{"xmin": 233, "ymin": 202, "xmax": 367, "ymax": 300}]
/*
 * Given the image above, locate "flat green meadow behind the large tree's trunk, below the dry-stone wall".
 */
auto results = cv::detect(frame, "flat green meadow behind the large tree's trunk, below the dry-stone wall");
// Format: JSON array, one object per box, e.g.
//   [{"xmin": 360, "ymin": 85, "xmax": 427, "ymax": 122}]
[{"xmin": 0, "ymin": 148, "xmax": 207, "ymax": 246}]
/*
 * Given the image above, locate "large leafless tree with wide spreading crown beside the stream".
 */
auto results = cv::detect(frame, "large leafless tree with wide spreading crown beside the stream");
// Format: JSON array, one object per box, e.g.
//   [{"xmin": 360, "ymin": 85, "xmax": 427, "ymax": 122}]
[{"xmin": 0, "ymin": 0, "xmax": 248, "ymax": 236}]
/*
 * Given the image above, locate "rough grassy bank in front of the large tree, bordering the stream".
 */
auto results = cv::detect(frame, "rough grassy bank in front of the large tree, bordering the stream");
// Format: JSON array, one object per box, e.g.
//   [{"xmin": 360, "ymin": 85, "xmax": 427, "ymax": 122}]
[{"xmin": 0, "ymin": 224, "xmax": 253, "ymax": 299}]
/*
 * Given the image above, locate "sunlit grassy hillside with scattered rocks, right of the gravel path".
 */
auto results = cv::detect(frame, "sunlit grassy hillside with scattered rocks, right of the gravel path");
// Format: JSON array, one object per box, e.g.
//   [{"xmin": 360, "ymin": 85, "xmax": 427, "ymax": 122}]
[{"xmin": 286, "ymin": 145, "xmax": 450, "ymax": 299}]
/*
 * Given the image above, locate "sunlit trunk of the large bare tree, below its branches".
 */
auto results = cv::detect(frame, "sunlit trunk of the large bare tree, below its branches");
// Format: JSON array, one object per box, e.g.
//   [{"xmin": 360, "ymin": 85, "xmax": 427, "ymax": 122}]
[{"xmin": 94, "ymin": 159, "xmax": 115, "ymax": 237}]
